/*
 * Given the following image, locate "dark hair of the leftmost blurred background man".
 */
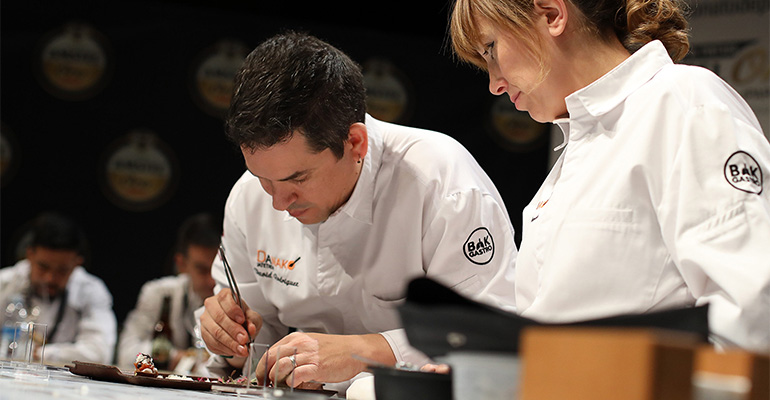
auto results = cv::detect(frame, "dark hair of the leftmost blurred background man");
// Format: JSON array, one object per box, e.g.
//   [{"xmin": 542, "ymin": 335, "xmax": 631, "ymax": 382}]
[{"xmin": 28, "ymin": 212, "xmax": 86, "ymax": 255}]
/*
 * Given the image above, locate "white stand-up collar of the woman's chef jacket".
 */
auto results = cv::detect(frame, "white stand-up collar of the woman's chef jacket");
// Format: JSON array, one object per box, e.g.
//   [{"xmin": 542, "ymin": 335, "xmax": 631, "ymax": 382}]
[{"xmin": 565, "ymin": 40, "xmax": 673, "ymax": 120}]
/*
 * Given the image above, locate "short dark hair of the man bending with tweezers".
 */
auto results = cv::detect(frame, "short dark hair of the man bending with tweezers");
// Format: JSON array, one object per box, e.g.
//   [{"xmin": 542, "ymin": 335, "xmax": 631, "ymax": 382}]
[{"xmin": 225, "ymin": 32, "xmax": 366, "ymax": 158}]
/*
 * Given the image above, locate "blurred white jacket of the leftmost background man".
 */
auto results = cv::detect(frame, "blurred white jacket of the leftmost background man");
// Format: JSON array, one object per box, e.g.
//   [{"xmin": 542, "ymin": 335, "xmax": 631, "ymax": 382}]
[{"xmin": 0, "ymin": 259, "xmax": 117, "ymax": 364}]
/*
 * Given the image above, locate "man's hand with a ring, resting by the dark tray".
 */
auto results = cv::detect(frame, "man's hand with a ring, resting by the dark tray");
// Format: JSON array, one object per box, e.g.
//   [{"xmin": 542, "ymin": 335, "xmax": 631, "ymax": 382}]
[{"xmin": 257, "ymin": 332, "xmax": 396, "ymax": 388}]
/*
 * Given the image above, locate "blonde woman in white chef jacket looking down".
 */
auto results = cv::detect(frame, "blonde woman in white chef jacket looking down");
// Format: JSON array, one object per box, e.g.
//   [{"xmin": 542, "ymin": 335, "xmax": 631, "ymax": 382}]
[{"xmin": 451, "ymin": 0, "xmax": 770, "ymax": 352}]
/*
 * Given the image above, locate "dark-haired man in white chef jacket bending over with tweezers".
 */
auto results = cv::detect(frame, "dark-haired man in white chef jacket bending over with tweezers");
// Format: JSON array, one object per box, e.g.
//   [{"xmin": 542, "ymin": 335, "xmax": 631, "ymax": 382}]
[{"xmin": 201, "ymin": 33, "xmax": 517, "ymax": 386}]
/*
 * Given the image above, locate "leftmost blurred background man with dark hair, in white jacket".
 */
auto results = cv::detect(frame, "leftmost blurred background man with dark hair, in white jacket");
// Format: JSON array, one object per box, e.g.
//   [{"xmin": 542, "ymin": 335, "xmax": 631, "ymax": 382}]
[{"xmin": 0, "ymin": 212, "xmax": 117, "ymax": 364}]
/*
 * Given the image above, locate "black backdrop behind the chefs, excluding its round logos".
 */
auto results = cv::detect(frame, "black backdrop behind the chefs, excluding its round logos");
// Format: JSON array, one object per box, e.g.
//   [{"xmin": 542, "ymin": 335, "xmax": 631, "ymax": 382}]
[{"xmin": 0, "ymin": 0, "xmax": 549, "ymax": 328}]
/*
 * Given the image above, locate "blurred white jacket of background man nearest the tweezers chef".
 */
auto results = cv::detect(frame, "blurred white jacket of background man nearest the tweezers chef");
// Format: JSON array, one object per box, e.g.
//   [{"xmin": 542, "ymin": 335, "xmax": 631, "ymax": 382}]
[{"xmin": 117, "ymin": 274, "xmax": 203, "ymax": 368}]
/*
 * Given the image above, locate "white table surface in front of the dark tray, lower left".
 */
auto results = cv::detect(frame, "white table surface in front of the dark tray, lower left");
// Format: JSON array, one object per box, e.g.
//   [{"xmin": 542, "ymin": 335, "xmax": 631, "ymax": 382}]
[{"xmin": 0, "ymin": 364, "xmax": 336, "ymax": 400}]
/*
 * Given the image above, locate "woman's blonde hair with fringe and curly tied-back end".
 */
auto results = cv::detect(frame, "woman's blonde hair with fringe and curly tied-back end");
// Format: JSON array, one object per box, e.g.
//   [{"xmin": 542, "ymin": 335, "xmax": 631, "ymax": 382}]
[{"xmin": 449, "ymin": 0, "xmax": 690, "ymax": 72}]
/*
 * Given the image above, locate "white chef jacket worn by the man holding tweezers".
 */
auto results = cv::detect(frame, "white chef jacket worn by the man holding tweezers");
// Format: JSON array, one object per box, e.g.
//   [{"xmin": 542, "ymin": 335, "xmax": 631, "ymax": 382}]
[{"xmin": 212, "ymin": 116, "xmax": 517, "ymax": 364}]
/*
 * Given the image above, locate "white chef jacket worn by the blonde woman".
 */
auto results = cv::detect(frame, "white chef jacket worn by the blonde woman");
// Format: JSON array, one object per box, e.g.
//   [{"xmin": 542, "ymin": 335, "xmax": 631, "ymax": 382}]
[{"xmin": 516, "ymin": 41, "xmax": 770, "ymax": 352}]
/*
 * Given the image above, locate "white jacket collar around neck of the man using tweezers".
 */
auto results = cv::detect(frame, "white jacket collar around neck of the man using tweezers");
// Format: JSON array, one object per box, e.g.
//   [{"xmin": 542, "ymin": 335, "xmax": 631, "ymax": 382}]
[{"xmin": 322, "ymin": 114, "xmax": 383, "ymax": 224}]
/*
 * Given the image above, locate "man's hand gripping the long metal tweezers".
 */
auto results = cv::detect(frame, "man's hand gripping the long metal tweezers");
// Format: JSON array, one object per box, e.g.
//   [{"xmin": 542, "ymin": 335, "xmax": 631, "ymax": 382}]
[{"xmin": 201, "ymin": 289, "xmax": 262, "ymax": 366}]
